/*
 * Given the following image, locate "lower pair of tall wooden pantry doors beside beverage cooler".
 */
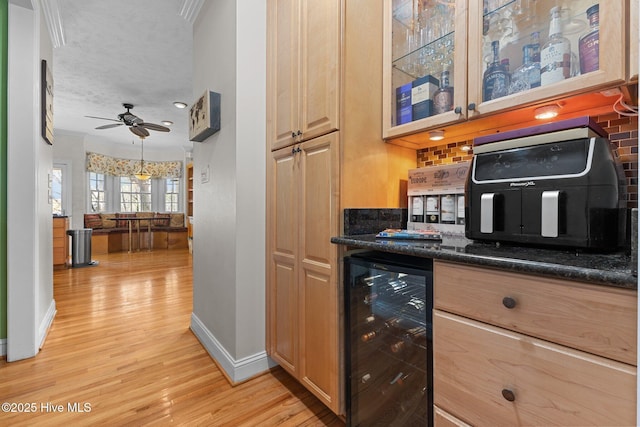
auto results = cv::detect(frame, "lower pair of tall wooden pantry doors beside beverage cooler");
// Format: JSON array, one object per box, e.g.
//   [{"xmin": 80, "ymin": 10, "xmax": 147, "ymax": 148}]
[{"xmin": 267, "ymin": 132, "xmax": 341, "ymax": 413}]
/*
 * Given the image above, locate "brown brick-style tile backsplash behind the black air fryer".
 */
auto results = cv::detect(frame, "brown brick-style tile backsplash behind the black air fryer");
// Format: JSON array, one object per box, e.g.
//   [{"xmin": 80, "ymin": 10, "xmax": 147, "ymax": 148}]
[{"xmin": 417, "ymin": 113, "xmax": 638, "ymax": 208}]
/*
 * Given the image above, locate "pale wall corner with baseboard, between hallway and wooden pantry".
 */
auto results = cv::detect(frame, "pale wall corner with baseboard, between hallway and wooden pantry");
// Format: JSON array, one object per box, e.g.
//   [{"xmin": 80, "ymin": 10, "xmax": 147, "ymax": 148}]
[{"xmin": 192, "ymin": 0, "xmax": 269, "ymax": 381}]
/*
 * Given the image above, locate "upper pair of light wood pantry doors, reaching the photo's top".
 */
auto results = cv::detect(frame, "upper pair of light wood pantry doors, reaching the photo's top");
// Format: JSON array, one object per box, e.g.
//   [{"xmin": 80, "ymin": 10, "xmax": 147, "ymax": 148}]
[{"xmin": 267, "ymin": 0, "xmax": 342, "ymax": 150}]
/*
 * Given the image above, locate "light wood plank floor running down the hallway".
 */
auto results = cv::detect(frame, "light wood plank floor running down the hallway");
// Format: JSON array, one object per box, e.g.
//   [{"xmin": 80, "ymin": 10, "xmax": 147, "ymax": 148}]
[{"xmin": 0, "ymin": 250, "xmax": 344, "ymax": 427}]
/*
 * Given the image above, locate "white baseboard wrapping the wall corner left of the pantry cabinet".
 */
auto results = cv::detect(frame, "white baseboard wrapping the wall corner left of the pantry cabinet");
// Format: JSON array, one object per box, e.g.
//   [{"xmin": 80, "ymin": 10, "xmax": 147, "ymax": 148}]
[{"xmin": 191, "ymin": 313, "xmax": 276, "ymax": 383}]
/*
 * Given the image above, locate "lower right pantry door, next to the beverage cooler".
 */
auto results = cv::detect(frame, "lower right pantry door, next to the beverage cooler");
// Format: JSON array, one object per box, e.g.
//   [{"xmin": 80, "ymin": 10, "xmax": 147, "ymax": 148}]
[{"xmin": 298, "ymin": 133, "xmax": 342, "ymax": 411}]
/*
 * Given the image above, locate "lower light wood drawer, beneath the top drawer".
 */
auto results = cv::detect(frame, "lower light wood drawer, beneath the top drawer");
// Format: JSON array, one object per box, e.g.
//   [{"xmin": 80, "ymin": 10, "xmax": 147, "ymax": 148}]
[{"xmin": 433, "ymin": 310, "xmax": 636, "ymax": 426}]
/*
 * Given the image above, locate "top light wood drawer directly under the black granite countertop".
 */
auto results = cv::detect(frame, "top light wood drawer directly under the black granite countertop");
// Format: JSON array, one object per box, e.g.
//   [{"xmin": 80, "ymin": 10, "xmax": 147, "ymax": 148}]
[{"xmin": 434, "ymin": 261, "xmax": 637, "ymax": 365}]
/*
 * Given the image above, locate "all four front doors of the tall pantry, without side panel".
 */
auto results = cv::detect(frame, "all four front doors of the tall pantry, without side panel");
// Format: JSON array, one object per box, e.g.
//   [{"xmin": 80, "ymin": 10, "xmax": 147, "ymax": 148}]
[{"xmin": 267, "ymin": 0, "xmax": 342, "ymax": 413}]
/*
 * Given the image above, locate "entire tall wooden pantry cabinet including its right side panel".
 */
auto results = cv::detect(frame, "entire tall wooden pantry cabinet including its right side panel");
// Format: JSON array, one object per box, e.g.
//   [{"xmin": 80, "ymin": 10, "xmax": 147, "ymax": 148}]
[{"xmin": 266, "ymin": 0, "xmax": 416, "ymax": 414}]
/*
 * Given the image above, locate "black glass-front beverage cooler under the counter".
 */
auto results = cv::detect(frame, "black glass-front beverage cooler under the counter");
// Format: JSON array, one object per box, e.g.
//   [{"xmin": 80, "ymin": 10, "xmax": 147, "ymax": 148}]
[{"xmin": 345, "ymin": 252, "xmax": 433, "ymax": 426}]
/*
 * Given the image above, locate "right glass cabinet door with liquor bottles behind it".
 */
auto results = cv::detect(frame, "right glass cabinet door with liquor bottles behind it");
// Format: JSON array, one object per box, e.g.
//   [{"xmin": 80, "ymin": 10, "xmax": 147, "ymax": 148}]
[{"xmin": 468, "ymin": 0, "xmax": 626, "ymax": 117}]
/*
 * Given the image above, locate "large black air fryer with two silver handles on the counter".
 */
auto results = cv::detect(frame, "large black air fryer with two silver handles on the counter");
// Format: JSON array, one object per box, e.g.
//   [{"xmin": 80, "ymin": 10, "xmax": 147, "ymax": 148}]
[{"xmin": 465, "ymin": 118, "xmax": 626, "ymax": 249}]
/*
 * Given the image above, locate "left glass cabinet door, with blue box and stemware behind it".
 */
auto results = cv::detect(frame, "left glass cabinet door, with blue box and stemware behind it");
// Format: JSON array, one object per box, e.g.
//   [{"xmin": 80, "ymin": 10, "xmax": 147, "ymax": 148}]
[{"xmin": 383, "ymin": 0, "xmax": 467, "ymax": 138}]
